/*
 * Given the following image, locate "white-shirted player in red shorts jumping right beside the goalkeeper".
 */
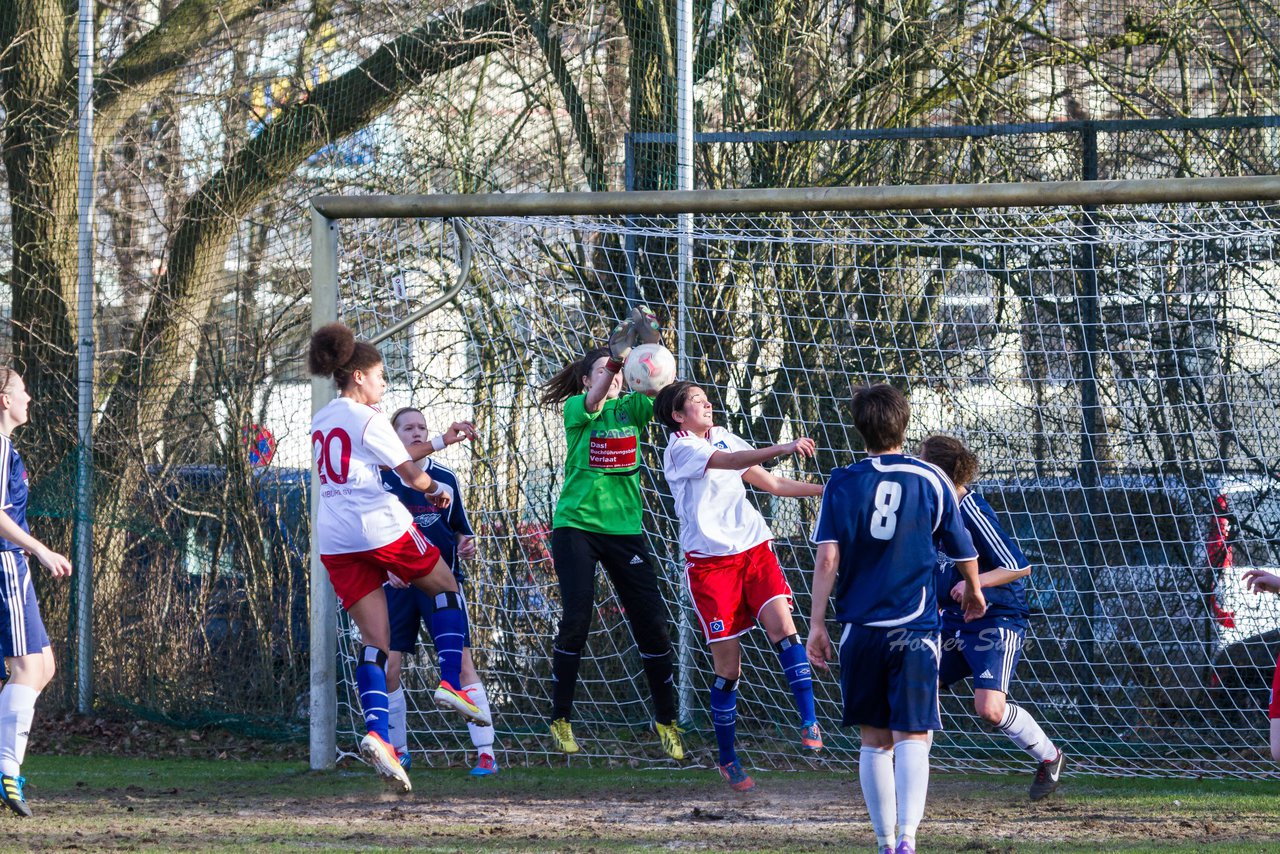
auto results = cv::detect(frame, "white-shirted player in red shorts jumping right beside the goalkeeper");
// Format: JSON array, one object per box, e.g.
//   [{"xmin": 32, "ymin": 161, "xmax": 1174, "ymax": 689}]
[{"xmin": 653, "ymin": 380, "xmax": 822, "ymax": 791}]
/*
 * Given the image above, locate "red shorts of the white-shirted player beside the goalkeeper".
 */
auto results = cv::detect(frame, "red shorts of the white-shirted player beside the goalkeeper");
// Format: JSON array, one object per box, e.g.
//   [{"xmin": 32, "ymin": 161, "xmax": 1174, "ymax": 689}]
[{"xmin": 685, "ymin": 540, "xmax": 792, "ymax": 643}]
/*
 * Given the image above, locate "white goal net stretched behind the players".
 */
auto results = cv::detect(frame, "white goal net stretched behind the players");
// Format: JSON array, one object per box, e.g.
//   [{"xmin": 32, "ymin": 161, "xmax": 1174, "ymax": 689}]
[{"xmin": 314, "ymin": 190, "xmax": 1280, "ymax": 776}]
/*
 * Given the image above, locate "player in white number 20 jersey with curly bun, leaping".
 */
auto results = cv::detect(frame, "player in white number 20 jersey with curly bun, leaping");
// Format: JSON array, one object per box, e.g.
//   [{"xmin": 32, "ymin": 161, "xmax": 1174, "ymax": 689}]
[{"xmin": 307, "ymin": 323, "xmax": 490, "ymax": 791}]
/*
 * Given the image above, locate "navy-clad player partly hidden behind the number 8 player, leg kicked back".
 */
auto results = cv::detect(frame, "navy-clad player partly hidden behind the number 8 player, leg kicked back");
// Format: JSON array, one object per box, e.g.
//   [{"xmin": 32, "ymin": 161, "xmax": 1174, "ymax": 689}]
[{"xmin": 920, "ymin": 435, "xmax": 1064, "ymax": 800}]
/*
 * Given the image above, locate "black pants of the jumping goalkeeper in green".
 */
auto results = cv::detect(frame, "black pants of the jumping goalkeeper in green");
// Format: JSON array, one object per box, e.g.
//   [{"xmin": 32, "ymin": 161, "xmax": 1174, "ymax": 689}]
[{"xmin": 552, "ymin": 528, "xmax": 676, "ymax": 723}]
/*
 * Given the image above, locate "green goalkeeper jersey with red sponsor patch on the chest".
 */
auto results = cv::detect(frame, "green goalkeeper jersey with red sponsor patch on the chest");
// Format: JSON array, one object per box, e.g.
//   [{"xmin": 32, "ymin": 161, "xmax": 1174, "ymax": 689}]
[{"xmin": 552, "ymin": 393, "xmax": 653, "ymax": 534}]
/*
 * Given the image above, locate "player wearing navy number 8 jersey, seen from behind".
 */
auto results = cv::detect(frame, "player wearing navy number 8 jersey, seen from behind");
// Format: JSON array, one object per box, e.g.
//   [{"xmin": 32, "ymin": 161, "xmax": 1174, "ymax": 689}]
[{"xmin": 805, "ymin": 384, "xmax": 987, "ymax": 854}]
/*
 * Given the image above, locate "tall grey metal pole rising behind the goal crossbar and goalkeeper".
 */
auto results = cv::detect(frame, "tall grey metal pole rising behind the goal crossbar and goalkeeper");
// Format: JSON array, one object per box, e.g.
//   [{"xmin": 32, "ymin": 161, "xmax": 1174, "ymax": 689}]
[{"xmin": 675, "ymin": 0, "xmax": 698, "ymax": 721}]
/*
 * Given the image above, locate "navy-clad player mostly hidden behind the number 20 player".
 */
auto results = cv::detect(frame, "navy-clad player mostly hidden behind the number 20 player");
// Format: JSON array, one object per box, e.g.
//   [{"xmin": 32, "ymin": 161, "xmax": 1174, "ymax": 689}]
[{"xmin": 383, "ymin": 406, "xmax": 498, "ymax": 777}]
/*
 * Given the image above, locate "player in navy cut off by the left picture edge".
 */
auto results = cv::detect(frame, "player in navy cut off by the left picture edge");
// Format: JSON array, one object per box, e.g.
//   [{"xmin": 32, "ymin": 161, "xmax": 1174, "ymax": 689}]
[{"xmin": 0, "ymin": 367, "xmax": 72, "ymax": 818}]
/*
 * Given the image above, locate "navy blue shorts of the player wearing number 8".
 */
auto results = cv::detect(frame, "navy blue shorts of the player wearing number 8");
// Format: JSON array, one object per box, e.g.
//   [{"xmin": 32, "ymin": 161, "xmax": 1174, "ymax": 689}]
[{"xmin": 840, "ymin": 622, "xmax": 942, "ymax": 732}]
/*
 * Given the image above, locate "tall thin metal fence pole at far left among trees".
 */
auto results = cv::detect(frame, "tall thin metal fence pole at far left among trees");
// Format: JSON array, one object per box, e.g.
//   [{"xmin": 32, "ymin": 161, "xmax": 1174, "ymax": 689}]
[{"xmin": 74, "ymin": 0, "xmax": 96, "ymax": 714}]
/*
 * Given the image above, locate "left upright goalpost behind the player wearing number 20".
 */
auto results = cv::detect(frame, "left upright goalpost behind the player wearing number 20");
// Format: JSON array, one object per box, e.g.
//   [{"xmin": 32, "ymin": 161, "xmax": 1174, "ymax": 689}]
[{"xmin": 310, "ymin": 210, "xmax": 338, "ymax": 771}]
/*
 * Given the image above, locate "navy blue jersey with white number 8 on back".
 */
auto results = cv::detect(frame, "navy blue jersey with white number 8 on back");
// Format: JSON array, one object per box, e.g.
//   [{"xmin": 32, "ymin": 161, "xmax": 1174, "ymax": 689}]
[{"xmin": 813, "ymin": 453, "xmax": 975, "ymax": 630}]
